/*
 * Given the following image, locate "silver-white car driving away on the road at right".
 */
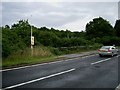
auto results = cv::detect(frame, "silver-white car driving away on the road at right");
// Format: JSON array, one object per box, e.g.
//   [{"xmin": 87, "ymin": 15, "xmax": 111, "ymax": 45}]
[{"xmin": 98, "ymin": 46, "xmax": 118, "ymax": 57}]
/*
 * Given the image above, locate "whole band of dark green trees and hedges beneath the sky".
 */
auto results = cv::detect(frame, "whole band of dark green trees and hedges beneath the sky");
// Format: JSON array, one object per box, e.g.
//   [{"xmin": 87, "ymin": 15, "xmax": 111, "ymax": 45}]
[{"xmin": 2, "ymin": 17, "xmax": 120, "ymax": 58}]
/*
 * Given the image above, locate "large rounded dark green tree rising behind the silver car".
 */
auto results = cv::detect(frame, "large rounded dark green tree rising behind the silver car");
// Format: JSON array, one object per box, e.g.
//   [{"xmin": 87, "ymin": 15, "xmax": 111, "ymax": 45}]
[{"xmin": 86, "ymin": 17, "xmax": 115, "ymax": 39}]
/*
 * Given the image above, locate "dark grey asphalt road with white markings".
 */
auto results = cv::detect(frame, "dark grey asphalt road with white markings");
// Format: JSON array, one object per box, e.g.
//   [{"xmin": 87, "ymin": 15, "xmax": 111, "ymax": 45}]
[{"xmin": 0, "ymin": 54, "xmax": 119, "ymax": 89}]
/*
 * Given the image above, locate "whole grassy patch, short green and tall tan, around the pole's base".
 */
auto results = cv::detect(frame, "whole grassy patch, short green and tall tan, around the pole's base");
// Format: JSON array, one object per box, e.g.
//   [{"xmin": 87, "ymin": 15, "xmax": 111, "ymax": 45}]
[{"xmin": 2, "ymin": 46, "xmax": 55, "ymax": 68}]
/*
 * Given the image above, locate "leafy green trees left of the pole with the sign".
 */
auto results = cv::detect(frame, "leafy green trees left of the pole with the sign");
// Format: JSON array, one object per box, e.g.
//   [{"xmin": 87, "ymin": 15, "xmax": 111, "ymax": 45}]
[{"xmin": 2, "ymin": 20, "xmax": 30, "ymax": 57}]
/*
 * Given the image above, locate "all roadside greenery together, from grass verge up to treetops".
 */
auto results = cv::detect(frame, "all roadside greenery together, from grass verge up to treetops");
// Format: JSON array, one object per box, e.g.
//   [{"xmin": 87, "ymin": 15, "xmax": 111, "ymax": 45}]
[{"xmin": 2, "ymin": 17, "xmax": 120, "ymax": 68}]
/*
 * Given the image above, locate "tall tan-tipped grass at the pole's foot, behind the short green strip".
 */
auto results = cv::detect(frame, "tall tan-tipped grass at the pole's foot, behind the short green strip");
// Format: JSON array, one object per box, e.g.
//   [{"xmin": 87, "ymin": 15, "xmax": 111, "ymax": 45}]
[{"xmin": 5, "ymin": 46, "xmax": 53, "ymax": 60}]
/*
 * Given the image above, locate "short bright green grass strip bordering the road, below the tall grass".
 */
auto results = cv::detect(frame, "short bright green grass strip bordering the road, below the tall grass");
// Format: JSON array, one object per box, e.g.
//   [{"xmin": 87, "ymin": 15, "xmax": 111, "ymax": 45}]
[{"xmin": 2, "ymin": 56, "xmax": 57, "ymax": 69}]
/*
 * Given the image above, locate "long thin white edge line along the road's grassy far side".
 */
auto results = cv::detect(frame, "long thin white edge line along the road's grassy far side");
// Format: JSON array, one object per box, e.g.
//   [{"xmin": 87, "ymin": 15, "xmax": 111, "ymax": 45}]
[{"xmin": 0, "ymin": 54, "xmax": 97, "ymax": 72}]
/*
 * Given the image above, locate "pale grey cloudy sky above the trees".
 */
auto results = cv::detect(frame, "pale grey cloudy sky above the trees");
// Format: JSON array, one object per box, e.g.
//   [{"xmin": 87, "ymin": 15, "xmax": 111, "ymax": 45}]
[{"xmin": 0, "ymin": 0, "xmax": 118, "ymax": 31}]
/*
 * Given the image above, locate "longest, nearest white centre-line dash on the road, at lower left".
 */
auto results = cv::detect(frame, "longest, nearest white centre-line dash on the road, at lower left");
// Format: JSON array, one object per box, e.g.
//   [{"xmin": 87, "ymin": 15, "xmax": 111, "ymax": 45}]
[{"xmin": 4, "ymin": 68, "xmax": 75, "ymax": 89}]
